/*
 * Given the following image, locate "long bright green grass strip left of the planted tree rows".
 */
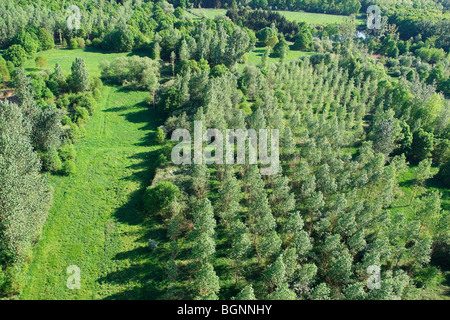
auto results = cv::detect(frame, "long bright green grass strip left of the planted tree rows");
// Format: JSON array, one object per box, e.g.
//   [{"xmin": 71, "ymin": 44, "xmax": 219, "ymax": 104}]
[{"xmin": 21, "ymin": 86, "xmax": 162, "ymax": 299}]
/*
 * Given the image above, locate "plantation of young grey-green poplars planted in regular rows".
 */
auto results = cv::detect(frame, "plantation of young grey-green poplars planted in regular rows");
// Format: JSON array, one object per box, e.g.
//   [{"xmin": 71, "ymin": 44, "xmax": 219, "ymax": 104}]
[{"xmin": 154, "ymin": 38, "xmax": 449, "ymax": 299}]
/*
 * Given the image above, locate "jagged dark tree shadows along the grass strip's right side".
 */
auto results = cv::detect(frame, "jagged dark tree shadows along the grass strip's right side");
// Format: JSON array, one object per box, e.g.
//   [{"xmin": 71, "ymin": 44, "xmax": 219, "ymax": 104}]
[{"xmin": 98, "ymin": 93, "xmax": 169, "ymax": 300}]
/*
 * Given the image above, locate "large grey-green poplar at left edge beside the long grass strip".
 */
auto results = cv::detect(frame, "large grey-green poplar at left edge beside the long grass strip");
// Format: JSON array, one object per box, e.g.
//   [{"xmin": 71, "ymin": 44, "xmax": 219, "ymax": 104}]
[{"xmin": 0, "ymin": 102, "xmax": 52, "ymax": 264}]
